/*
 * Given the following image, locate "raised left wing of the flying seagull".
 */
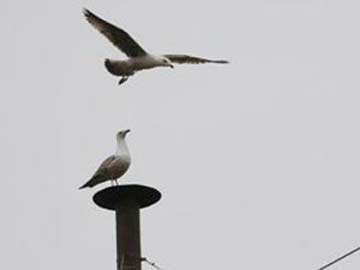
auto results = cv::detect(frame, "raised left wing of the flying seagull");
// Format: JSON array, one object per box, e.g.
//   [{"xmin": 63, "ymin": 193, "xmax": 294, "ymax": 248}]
[{"xmin": 84, "ymin": 9, "xmax": 147, "ymax": 57}]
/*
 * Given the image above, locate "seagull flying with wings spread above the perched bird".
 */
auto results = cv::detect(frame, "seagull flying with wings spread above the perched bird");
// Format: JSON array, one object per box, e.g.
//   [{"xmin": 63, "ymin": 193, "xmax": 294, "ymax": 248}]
[{"xmin": 84, "ymin": 9, "xmax": 229, "ymax": 85}]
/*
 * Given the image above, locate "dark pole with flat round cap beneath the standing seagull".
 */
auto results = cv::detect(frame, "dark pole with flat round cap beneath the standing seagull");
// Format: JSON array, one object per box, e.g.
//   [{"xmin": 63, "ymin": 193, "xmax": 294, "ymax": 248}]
[{"xmin": 93, "ymin": 185, "xmax": 161, "ymax": 270}]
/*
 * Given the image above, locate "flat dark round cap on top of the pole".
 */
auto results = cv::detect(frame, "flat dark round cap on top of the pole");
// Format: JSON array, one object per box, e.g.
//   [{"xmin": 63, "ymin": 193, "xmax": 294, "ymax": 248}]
[{"xmin": 93, "ymin": 185, "xmax": 161, "ymax": 210}]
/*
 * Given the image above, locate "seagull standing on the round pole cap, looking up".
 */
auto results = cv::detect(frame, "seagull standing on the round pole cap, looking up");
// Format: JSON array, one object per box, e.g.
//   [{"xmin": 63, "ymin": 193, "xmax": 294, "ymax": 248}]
[{"xmin": 79, "ymin": 129, "xmax": 131, "ymax": 189}]
